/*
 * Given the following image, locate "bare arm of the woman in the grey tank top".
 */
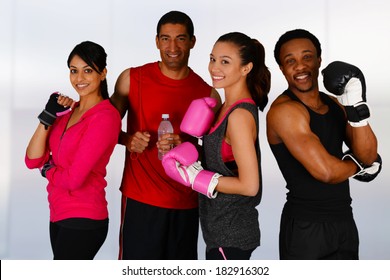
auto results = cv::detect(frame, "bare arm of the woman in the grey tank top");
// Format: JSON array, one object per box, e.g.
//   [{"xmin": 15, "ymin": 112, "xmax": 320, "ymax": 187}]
[{"xmin": 217, "ymin": 109, "xmax": 260, "ymax": 196}]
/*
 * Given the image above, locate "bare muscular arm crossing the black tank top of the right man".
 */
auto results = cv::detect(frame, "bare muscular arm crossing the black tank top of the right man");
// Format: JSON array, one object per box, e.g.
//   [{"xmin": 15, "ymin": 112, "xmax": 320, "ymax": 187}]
[{"xmin": 267, "ymin": 98, "xmax": 357, "ymax": 183}]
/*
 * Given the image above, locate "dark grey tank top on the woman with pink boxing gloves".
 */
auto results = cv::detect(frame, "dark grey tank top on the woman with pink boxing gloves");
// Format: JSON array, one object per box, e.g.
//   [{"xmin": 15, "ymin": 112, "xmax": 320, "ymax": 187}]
[{"xmin": 199, "ymin": 102, "xmax": 262, "ymax": 250}]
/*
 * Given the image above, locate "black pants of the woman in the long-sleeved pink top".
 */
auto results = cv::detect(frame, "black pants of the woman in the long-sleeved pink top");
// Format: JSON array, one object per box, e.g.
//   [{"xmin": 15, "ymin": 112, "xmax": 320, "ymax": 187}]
[{"xmin": 50, "ymin": 219, "xmax": 108, "ymax": 260}]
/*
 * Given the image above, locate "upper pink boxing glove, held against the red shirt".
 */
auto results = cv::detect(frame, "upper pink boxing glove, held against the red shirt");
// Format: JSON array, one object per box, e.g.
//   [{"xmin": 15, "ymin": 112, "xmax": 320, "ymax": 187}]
[{"xmin": 180, "ymin": 97, "xmax": 217, "ymax": 138}]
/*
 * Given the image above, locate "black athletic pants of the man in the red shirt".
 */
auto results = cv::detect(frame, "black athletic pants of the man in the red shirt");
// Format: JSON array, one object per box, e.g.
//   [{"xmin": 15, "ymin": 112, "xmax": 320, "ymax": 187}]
[{"xmin": 119, "ymin": 197, "xmax": 199, "ymax": 260}]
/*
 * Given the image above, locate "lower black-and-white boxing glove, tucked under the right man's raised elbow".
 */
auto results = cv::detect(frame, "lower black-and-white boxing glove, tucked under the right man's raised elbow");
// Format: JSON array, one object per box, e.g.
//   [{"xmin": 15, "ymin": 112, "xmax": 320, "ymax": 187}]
[{"xmin": 342, "ymin": 150, "xmax": 382, "ymax": 182}]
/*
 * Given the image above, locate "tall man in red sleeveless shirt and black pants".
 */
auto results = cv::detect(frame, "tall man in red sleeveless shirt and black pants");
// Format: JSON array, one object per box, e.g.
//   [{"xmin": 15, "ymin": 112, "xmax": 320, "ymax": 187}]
[{"xmin": 111, "ymin": 11, "xmax": 220, "ymax": 259}]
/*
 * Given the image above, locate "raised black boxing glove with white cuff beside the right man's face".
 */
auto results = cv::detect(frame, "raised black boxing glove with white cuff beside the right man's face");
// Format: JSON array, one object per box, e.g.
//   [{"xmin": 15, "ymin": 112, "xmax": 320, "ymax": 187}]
[{"xmin": 321, "ymin": 61, "xmax": 370, "ymax": 127}]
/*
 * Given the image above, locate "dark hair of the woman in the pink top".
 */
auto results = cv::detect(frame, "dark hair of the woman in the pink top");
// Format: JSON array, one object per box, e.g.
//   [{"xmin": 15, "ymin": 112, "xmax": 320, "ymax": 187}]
[{"xmin": 67, "ymin": 41, "xmax": 109, "ymax": 99}]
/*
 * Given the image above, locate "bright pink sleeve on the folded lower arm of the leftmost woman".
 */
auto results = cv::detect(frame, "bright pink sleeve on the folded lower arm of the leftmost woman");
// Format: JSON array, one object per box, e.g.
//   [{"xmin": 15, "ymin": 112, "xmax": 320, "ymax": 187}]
[{"xmin": 46, "ymin": 111, "xmax": 121, "ymax": 191}]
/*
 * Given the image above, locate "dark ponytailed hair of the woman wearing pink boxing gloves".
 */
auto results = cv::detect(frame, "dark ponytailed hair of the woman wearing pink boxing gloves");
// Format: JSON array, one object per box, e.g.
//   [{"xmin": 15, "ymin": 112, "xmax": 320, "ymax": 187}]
[{"xmin": 217, "ymin": 32, "xmax": 271, "ymax": 111}]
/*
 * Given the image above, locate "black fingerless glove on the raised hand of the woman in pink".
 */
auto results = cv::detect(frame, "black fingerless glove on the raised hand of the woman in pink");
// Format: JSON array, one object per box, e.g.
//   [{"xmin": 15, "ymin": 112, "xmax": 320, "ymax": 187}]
[{"xmin": 38, "ymin": 92, "xmax": 71, "ymax": 129}]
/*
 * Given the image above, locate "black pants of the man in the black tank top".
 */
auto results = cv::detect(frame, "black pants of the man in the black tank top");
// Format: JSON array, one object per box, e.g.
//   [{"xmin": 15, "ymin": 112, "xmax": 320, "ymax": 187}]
[{"xmin": 279, "ymin": 215, "xmax": 359, "ymax": 260}]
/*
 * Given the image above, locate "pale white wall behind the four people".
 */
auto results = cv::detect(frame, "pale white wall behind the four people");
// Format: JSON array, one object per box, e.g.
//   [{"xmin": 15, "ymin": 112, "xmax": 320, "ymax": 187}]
[{"xmin": 0, "ymin": 0, "xmax": 390, "ymax": 260}]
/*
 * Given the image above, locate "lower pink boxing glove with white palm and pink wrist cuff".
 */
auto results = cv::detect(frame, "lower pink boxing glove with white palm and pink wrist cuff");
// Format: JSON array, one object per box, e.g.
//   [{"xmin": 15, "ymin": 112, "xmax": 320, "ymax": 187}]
[{"xmin": 162, "ymin": 142, "xmax": 222, "ymax": 198}]
